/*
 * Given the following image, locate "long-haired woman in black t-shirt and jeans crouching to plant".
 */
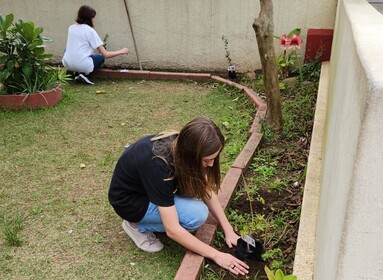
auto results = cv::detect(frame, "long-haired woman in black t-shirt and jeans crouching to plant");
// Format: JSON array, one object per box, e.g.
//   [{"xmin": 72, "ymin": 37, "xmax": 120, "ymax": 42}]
[{"xmin": 109, "ymin": 118, "xmax": 249, "ymax": 275}]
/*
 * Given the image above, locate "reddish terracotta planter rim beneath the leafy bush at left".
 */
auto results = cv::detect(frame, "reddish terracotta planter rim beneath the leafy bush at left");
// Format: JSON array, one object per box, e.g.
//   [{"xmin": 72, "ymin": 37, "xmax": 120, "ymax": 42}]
[{"xmin": 0, "ymin": 86, "xmax": 62, "ymax": 110}]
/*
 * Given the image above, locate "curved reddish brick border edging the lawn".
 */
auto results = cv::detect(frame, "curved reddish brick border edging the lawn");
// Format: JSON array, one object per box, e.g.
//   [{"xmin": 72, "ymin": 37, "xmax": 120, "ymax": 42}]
[{"xmin": 95, "ymin": 69, "xmax": 267, "ymax": 280}]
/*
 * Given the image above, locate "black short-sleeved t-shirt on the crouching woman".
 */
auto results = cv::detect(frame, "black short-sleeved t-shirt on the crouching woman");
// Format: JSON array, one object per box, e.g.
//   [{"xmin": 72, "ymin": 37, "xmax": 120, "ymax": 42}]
[{"xmin": 108, "ymin": 135, "xmax": 177, "ymax": 222}]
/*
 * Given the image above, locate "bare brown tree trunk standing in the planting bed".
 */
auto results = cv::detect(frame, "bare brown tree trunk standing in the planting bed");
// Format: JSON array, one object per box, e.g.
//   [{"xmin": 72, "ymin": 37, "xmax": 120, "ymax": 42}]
[{"xmin": 253, "ymin": 0, "xmax": 283, "ymax": 130}]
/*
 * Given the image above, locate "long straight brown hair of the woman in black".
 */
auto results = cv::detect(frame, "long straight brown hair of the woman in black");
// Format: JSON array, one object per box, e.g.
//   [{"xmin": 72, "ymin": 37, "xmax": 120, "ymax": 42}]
[{"xmin": 174, "ymin": 117, "xmax": 225, "ymax": 199}]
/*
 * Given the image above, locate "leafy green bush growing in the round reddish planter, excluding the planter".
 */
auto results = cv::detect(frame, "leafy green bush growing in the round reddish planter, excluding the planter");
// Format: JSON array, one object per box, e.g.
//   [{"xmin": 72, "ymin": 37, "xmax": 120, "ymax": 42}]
[{"xmin": 0, "ymin": 14, "xmax": 69, "ymax": 94}]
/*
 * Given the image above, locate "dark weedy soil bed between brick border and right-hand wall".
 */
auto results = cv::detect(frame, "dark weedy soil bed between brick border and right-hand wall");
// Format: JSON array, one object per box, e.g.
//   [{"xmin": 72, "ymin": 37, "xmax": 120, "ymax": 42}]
[{"xmin": 201, "ymin": 77, "xmax": 317, "ymax": 280}]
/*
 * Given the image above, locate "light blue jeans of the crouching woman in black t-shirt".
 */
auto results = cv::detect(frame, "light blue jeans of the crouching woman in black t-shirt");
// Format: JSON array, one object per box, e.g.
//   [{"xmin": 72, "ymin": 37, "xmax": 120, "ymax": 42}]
[{"xmin": 137, "ymin": 195, "xmax": 209, "ymax": 232}]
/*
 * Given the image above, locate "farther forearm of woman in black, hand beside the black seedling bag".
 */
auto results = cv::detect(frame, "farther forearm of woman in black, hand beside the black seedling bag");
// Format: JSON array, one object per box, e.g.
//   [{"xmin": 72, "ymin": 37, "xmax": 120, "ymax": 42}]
[{"xmin": 204, "ymin": 192, "xmax": 240, "ymax": 248}]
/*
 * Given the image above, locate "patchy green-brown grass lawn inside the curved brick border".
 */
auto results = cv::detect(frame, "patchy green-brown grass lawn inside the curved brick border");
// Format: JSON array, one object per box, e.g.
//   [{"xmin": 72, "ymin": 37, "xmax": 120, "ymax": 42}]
[{"xmin": 0, "ymin": 80, "xmax": 254, "ymax": 279}]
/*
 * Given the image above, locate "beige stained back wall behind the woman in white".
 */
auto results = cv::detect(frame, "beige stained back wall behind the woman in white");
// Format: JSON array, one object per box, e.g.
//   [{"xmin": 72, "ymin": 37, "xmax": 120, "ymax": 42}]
[{"xmin": 0, "ymin": 0, "xmax": 336, "ymax": 72}]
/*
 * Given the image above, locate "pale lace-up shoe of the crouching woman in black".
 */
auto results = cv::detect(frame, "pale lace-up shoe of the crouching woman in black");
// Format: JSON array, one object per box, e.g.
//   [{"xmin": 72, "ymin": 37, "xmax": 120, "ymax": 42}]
[{"xmin": 122, "ymin": 220, "xmax": 164, "ymax": 253}]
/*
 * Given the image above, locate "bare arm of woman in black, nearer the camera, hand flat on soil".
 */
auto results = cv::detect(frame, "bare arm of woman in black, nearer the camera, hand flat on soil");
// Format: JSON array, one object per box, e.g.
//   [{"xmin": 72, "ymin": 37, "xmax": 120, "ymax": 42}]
[{"xmin": 158, "ymin": 206, "xmax": 249, "ymax": 275}]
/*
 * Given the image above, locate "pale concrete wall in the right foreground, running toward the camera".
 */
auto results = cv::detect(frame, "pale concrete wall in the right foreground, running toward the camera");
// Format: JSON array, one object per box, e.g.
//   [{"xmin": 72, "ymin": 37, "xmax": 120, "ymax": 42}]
[{"xmin": 314, "ymin": 0, "xmax": 383, "ymax": 280}]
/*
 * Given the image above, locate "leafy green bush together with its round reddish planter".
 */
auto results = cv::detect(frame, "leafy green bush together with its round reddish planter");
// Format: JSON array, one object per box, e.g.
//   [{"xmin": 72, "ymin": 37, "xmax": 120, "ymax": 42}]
[{"xmin": 0, "ymin": 14, "xmax": 69, "ymax": 110}]
